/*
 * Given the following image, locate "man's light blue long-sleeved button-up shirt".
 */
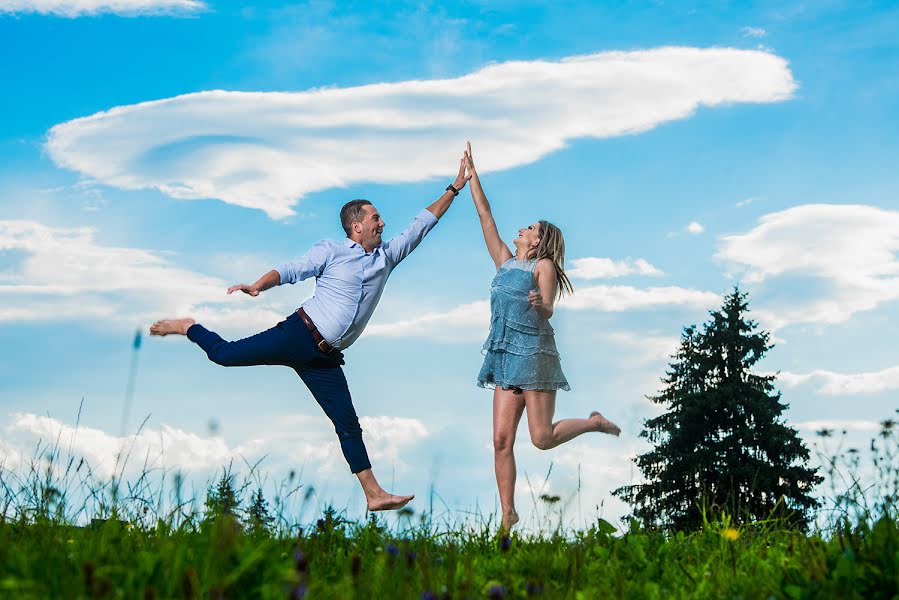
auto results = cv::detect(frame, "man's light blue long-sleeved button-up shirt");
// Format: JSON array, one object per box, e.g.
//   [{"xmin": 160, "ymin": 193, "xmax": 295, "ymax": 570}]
[{"xmin": 276, "ymin": 209, "xmax": 437, "ymax": 350}]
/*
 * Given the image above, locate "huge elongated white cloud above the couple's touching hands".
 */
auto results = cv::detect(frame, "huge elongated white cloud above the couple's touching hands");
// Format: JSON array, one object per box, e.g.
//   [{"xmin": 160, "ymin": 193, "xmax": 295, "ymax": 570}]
[{"xmin": 46, "ymin": 47, "xmax": 796, "ymax": 218}]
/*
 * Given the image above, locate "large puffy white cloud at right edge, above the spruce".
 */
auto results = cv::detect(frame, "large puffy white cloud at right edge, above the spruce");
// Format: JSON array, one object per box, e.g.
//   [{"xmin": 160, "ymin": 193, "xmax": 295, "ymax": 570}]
[{"xmin": 716, "ymin": 204, "xmax": 899, "ymax": 327}]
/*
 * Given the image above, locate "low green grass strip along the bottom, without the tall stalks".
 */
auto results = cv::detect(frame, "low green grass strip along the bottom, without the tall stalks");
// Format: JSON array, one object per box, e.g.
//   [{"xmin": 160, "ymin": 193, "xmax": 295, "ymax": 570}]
[{"xmin": 0, "ymin": 508, "xmax": 899, "ymax": 598}]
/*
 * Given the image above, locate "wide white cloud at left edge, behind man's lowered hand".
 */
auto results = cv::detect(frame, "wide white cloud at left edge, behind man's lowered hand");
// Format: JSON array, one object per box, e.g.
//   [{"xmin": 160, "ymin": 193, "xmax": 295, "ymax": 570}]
[{"xmin": 0, "ymin": 221, "xmax": 311, "ymax": 332}]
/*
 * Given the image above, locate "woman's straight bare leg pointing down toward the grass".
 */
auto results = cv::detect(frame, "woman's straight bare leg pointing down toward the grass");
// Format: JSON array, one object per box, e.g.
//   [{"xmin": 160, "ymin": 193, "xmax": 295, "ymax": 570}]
[{"xmin": 493, "ymin": 388, "xmax": 524, "ymax": 531}]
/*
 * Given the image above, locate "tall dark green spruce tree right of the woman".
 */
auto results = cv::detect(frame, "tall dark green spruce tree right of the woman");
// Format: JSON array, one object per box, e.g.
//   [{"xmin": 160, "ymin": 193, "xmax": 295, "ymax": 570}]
[{"xmin": 613, "ymin": 288, "xmax": 821, "ymax": 530}]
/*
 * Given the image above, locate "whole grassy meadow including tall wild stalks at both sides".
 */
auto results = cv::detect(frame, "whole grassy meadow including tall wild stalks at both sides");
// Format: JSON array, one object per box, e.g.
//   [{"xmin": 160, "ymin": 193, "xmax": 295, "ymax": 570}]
[{"xmin": 0, "ymin": 414, "xmax": 899, "ymax": 599}]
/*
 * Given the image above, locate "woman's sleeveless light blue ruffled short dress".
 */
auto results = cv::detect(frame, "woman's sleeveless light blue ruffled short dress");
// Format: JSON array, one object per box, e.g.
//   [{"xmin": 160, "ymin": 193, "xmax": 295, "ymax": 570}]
[{"xmin": 478, "ymin": 258, "xmax": 571, "ymax": 390}]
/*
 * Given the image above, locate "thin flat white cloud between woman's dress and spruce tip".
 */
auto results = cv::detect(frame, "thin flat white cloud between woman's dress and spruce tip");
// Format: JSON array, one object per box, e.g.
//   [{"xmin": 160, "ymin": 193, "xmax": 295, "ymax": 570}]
[{"xmin": 559, "ymin": 285, "xmax": 721, "ymax": 312}]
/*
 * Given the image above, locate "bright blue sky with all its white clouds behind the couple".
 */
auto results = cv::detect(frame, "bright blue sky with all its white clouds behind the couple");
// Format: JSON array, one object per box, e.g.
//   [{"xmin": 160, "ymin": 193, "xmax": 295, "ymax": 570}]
[{"xmin": 0, "ymin": 0, "xmax": 899, "ymax": 527}]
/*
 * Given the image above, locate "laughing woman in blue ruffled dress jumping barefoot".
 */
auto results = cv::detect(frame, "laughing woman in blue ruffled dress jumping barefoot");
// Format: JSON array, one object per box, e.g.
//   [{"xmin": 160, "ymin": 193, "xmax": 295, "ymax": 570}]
[{"xmin": 465, "ymin": 144, "xmax": 621, "ymax": 531}]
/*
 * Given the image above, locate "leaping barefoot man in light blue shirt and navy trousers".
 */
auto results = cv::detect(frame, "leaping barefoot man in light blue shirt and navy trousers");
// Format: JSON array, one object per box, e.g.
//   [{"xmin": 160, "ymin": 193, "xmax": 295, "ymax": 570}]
[{"xmin": 150, "ymin": 162, "xmax": 471, "ymax": 511}]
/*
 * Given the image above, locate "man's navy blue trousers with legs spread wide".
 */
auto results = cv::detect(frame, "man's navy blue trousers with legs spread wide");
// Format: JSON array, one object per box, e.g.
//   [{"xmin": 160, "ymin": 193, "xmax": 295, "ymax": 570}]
[{"xmin": 187, "ymin": 313, "xmax": 371, "ymax": 473}]
